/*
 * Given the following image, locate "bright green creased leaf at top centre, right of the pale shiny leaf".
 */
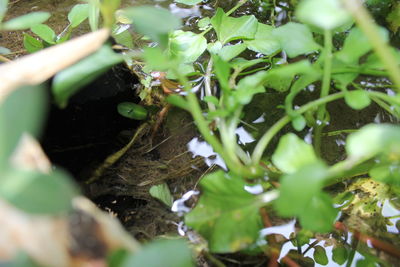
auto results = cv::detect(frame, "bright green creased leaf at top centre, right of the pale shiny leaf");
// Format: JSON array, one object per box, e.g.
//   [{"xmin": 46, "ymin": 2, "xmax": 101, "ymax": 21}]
[{"xmin": 211, "ymin": 8, "xmax": 258, "ymax": 44}]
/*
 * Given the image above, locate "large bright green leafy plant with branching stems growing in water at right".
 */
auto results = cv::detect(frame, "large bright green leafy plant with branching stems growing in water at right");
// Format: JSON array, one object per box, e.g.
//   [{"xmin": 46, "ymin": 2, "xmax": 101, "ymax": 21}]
[{"xmin": 114, "ymin": 0, "xmax": 400, "ymax": 264}]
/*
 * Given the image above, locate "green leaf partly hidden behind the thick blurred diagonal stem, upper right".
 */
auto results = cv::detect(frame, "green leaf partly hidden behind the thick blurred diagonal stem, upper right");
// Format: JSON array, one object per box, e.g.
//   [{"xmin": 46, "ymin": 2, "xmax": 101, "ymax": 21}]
[{"xmin": 335, "ymin": 27, "xmax": 389, "ymax": 63}]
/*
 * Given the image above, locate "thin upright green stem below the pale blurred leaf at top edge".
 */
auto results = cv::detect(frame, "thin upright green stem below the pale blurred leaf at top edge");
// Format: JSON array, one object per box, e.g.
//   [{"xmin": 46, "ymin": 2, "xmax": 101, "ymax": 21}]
[{"xmin": 314, "ymin": 30, "xmax": 332, "ymax": 156}]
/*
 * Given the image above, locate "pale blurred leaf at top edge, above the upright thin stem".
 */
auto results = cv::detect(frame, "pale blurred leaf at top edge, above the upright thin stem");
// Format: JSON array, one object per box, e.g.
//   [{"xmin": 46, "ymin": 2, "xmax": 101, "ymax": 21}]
[{"xmin": 296, "ymin": 0, "xmax": 352, "ymax": 30}]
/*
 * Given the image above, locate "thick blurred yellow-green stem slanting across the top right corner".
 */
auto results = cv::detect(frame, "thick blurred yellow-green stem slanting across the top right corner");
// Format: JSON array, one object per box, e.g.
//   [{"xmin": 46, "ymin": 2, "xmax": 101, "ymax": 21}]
[{"xmin": 342, "ymin": 0, "xmax": 400, "ymax": 92}]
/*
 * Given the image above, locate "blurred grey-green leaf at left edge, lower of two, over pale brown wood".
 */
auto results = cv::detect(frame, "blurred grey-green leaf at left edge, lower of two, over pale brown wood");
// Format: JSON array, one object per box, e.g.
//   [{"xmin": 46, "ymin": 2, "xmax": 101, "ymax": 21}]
[{"xmin": 0, "ymin": 169, "xmax": 77, "ymax": 214}]
